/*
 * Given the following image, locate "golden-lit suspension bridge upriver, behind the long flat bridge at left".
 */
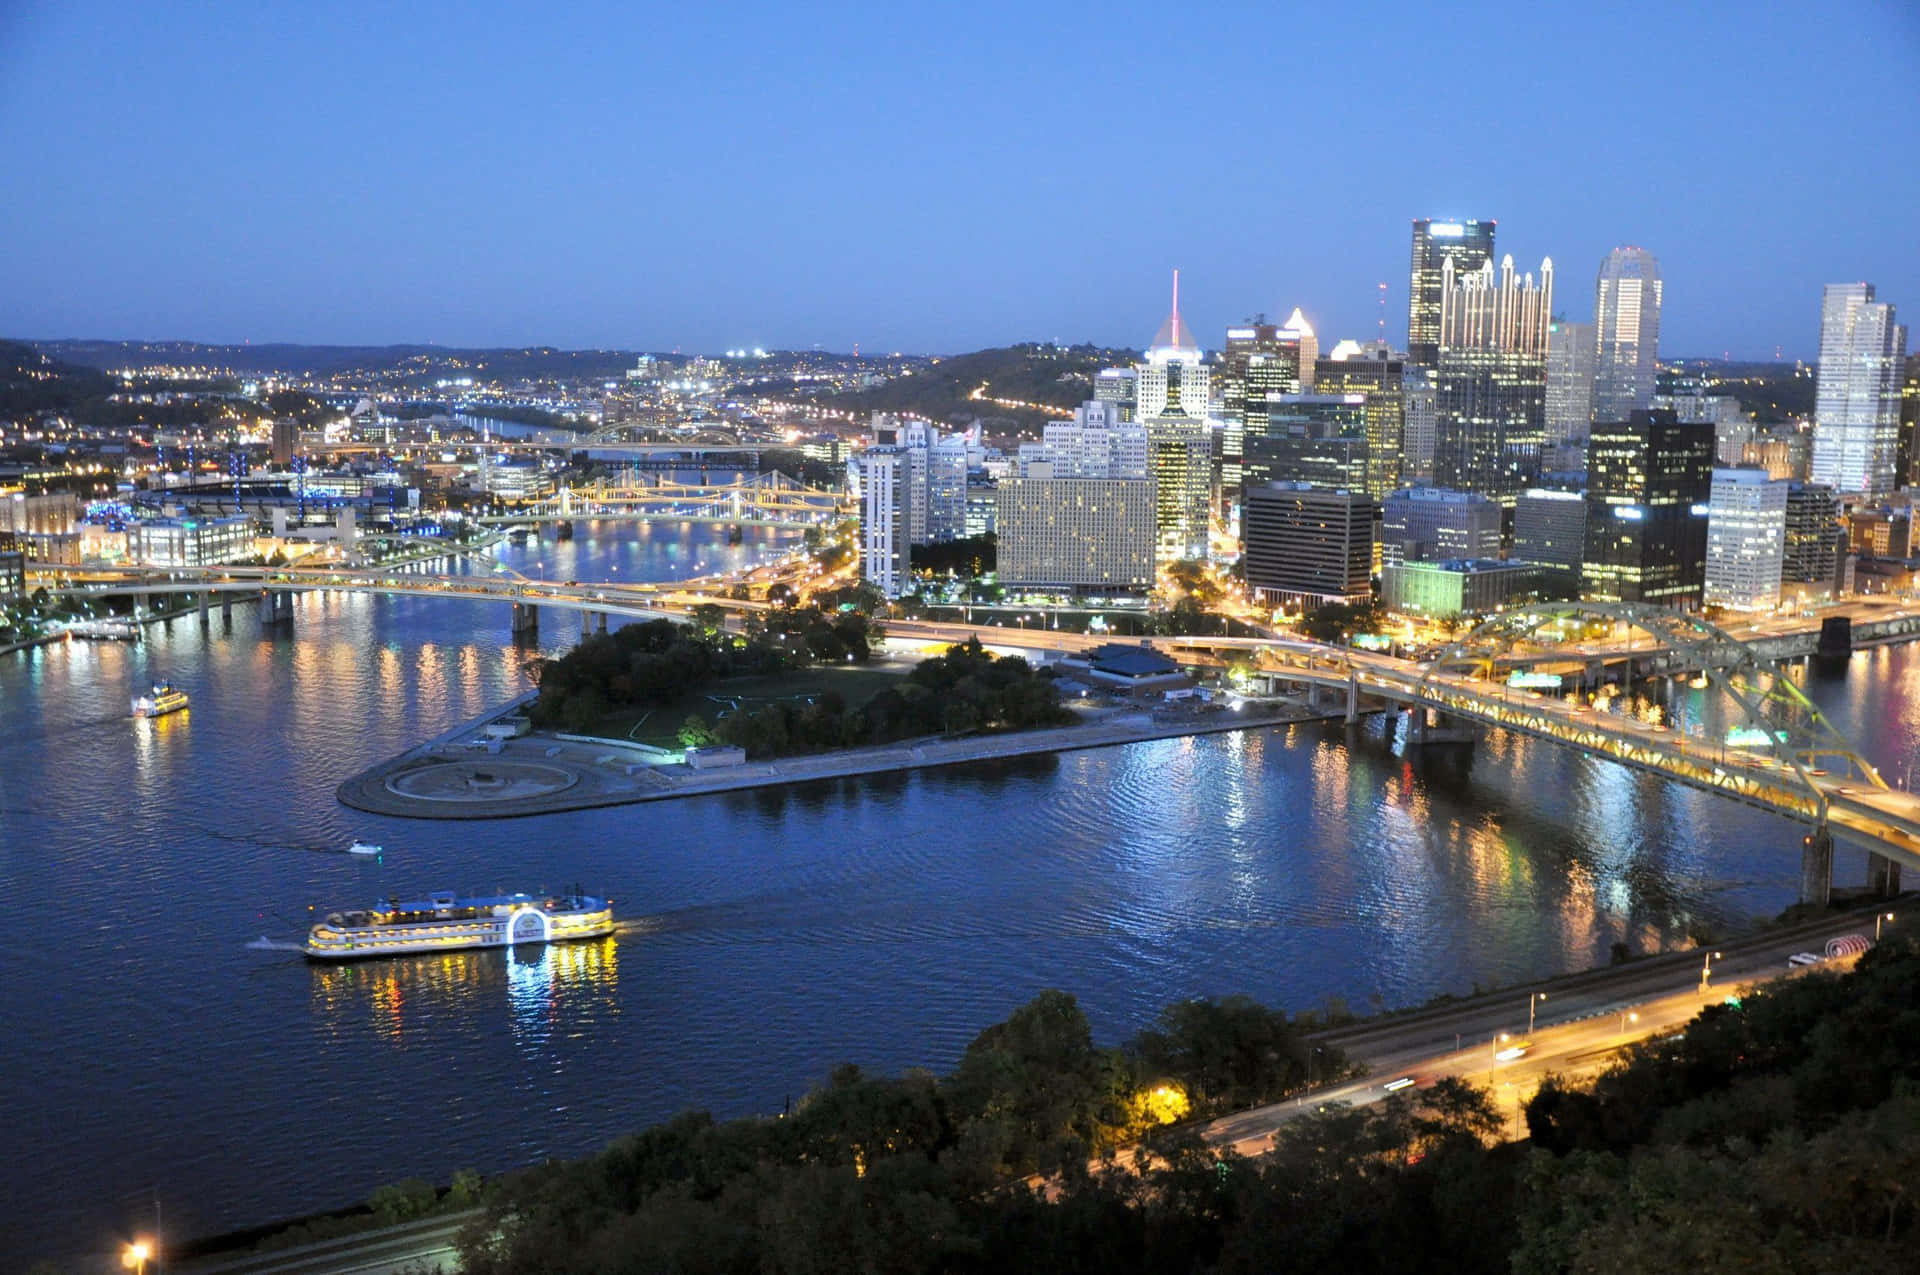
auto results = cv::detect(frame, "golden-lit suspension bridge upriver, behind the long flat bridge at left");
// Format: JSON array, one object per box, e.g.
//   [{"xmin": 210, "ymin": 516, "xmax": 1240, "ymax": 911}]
[{"xmin": 482, "ymin": 472, "xmax": 849, "ymax": 528}]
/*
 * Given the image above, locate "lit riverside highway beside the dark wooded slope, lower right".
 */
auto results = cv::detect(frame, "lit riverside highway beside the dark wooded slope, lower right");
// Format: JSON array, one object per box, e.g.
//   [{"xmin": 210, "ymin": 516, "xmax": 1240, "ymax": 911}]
[{"xmin": 1202, "ymin": 912, "xmax": 1901, "ymax": 1156}]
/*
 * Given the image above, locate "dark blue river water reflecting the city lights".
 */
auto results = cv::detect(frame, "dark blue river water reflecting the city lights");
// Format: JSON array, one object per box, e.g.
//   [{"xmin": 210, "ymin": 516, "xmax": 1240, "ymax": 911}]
[{"xmin": 0, "ymin": 524, "xmax": 1920, "ymax": 1262}]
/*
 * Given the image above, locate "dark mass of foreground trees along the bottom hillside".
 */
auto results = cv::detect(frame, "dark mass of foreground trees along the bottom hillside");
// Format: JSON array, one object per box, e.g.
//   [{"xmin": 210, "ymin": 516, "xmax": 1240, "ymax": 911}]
[{"xmin": 459, "ymin": 941, "xmax": 1920, "ymax": 1275}]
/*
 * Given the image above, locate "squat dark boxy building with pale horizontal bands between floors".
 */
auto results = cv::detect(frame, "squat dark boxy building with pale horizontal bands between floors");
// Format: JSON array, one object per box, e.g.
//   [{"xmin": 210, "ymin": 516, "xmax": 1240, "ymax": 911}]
[{"xmin": 1240, "ymin": 482, "xmax": 1377, "ymax": 607}]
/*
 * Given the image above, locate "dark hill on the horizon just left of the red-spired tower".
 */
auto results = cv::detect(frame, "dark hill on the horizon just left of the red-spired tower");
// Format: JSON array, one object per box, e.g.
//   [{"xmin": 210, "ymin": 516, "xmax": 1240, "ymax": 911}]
[{"xmin": 822, "ymin": 344, "xmax": 1137, "ymax": 424}]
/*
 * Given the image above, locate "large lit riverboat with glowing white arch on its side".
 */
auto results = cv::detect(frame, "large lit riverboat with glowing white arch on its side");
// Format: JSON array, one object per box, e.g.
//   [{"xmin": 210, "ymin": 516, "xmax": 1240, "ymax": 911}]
[{"xmin": 305, "ymin": 891, "xmax": 612, "ymax": 960}]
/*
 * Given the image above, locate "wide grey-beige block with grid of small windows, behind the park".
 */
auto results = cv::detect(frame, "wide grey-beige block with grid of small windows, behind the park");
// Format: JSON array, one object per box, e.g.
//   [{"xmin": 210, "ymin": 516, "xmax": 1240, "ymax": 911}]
[{"xmin": 996, "ymin": 476, "xmax": 1154, "ymax": 595}]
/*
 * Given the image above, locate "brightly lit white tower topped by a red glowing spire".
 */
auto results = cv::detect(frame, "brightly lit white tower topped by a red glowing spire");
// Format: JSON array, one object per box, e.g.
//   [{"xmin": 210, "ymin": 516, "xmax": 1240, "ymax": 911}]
[{"xmin": 1135, "ymin": 271, "xmax": 1213, "ymax": 563}]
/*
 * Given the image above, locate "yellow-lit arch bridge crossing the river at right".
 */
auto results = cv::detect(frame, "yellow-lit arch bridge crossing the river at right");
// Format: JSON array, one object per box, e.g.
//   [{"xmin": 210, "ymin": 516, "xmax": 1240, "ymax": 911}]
[{"xmin": 1228, "ymin": 603, "xmax": 1920, "ymax": 895}]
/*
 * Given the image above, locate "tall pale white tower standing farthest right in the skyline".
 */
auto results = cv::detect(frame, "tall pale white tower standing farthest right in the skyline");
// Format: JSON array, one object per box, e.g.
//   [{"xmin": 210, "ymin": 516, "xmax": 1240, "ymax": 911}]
[{"xmin": 1809, "ymin": 284, "xmax": 1907, "ymax": 497}]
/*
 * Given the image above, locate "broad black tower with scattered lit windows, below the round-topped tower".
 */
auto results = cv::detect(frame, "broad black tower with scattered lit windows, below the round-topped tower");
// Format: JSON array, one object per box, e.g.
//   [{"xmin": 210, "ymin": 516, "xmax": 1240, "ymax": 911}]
[{"xmin": 1580, "ymin": 411, "xmax": 1713, "ymax": 607}]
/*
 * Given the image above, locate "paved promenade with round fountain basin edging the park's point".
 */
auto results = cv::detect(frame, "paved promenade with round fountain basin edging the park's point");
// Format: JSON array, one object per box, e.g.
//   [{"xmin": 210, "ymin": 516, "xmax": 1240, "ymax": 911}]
[{"xmin": 334, "ymin": 697, "xmax": 1342, "ymax": 820}]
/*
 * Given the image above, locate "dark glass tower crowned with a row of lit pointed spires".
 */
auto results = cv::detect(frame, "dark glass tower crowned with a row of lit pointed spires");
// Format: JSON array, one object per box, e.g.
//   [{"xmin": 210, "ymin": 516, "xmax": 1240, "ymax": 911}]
[{"xmin": 1434, "ymin": 255, "xmax": 1553, "ymax": 507}]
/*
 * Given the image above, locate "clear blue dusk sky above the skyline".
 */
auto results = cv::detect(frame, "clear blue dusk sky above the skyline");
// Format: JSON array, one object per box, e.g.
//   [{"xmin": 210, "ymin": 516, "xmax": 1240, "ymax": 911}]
[{"xmin": 0, "ymin": 0, "xmax": 1920, "ymax": 357}]
